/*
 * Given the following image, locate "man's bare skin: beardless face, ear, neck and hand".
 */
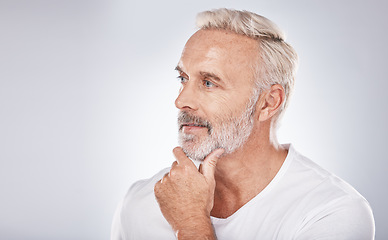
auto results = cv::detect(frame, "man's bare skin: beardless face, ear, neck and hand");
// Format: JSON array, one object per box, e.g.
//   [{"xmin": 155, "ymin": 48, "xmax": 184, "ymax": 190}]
[{"xmin": 155, "ymin": 30, "xmax": 287, "ymax": 239}]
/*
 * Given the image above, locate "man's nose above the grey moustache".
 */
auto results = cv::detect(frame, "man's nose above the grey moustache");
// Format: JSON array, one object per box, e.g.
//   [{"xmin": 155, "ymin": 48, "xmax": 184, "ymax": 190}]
[{"xmin": 175, "ymin": 81, "xmax": 198, "ymax": 110}]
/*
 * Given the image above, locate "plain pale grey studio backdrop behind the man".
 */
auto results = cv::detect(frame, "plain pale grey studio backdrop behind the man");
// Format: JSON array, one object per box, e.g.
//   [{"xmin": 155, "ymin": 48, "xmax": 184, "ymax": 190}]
[{"xmin": 0, "ymin": 0, "xmax": 388, "ymax": 240}]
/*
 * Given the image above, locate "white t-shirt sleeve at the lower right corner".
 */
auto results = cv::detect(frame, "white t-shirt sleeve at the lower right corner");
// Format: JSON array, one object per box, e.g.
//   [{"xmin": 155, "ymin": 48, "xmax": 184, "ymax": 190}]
[{"xmin": 294, "ymin": 197, "xmax": 375, "ymax": 240}]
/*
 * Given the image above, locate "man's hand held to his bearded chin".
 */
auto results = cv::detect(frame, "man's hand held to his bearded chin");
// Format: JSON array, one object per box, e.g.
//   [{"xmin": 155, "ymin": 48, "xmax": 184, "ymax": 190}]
[{"xmin": 154, "ymin": 147, "xmax": 224, "ymax": 239}]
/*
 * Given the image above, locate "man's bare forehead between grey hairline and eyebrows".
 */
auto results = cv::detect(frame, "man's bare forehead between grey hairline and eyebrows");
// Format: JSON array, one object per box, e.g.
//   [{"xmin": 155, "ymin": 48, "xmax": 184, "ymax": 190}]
[{"xmin": 178, "ymin": 30, "xmax": 259, "ymax": 83}]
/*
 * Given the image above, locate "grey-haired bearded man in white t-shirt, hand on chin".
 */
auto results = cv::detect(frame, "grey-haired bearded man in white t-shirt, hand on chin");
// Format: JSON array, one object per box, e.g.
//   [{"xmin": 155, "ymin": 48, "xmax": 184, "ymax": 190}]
[{"xmin": 112, "ymin": 9, "xmax": 374, "ymax": 240}]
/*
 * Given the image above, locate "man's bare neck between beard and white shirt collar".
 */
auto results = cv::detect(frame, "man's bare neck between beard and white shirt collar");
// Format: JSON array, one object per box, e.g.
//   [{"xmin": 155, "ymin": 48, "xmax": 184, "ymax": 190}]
[{"xmin": 212, "ymin": 123, "xmax": 287, "ymax": 218}]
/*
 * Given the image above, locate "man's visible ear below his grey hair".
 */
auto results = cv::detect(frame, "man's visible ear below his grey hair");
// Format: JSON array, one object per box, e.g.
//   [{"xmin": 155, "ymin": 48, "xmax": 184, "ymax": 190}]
[{"xmin": 259, "ymin": 84, "xmax": 285, "ymax": 121}]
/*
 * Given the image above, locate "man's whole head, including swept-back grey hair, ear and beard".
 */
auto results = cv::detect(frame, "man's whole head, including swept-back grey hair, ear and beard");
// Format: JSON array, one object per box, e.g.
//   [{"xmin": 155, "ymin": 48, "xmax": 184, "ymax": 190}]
[{"xmin": 176, "ymin": 9, "xmax": 297, "ymax": 160}]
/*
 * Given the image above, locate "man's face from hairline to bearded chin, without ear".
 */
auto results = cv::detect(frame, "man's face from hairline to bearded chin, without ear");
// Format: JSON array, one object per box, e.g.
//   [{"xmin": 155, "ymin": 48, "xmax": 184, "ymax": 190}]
[{"xmin": 175, "ymin": 30, "xmax": 259, "ymax": 160}]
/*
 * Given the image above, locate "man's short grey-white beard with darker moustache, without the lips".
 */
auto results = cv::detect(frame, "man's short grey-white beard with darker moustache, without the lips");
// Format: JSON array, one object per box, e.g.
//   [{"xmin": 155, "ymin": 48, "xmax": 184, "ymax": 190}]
[{"xmin": 178, "ymin": 94, "xmax": 258, "ymax": 161}]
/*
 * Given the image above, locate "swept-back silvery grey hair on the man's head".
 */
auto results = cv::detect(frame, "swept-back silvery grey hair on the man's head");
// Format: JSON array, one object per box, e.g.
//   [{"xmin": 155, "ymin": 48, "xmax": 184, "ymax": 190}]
[{"xmin": 197, "ymin": 8, "xmax": 298, "ymax": 128}]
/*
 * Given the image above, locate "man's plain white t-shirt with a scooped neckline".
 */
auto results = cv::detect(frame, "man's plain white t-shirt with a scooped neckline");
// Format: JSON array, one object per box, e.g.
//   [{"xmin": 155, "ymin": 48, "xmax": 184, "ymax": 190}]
[{"xmin": 111, "ymin": 145, "xmax": 375, "ymax": 240}]
